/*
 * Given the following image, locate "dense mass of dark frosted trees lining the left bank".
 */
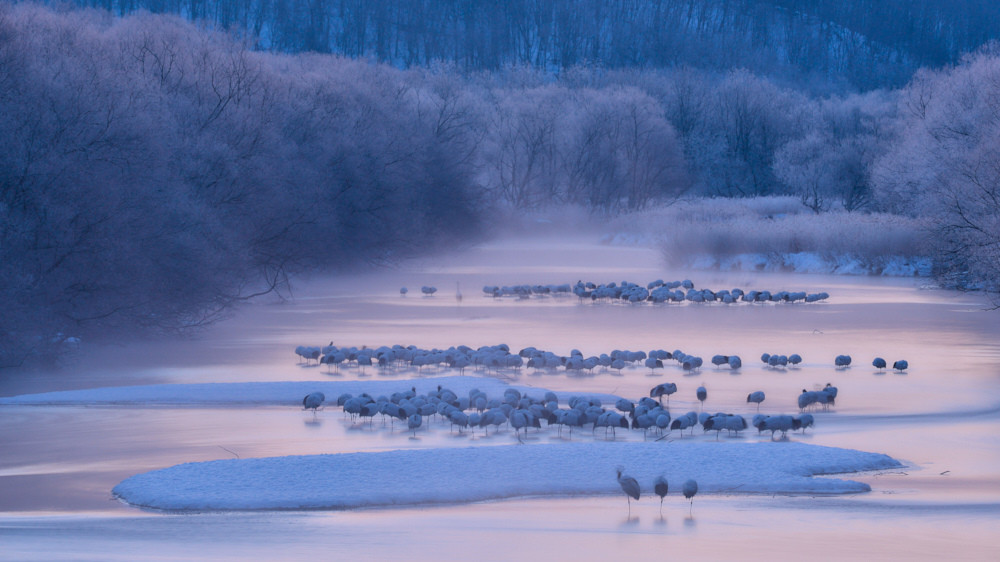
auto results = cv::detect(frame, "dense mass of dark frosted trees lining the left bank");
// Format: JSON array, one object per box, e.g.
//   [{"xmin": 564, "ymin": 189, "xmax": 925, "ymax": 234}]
[{"xmin": 0, "ymin": 4, "xmax": 481, "ymax": 366}]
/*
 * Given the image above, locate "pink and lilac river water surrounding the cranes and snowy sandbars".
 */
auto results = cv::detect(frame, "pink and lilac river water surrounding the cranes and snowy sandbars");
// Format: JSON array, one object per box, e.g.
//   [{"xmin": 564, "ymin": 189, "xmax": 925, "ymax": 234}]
[{"xmin": 0, "ymin": 234, "xmax": 1000, "ymax": 560}]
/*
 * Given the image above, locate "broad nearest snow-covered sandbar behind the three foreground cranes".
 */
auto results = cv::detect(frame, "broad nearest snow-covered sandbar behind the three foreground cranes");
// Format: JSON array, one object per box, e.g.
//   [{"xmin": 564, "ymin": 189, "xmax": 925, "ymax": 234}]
[{"xmin": 113, "ymin": 442, "xmax": 902, "ymax": 510}]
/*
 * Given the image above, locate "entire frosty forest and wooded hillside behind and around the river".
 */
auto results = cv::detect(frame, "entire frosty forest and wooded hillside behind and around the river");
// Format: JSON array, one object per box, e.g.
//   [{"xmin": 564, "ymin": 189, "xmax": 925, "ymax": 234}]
[{"xmin": 0, "ymin": 0, "xmax": 1000, "ymax": 367}]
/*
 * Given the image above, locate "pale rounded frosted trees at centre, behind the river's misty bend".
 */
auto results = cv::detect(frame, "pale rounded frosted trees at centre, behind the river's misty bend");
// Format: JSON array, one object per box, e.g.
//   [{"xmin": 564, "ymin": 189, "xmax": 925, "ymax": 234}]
[{"xmin": 483, "ymin": 85, "xmax": 688, "ymax": 212}]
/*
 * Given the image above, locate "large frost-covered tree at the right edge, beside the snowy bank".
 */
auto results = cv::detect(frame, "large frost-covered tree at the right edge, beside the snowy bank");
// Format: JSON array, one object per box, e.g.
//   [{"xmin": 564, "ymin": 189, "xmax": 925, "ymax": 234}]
[{"xmin": 873, "ymin": 47, "xmax": 1000, "ymax": 291}]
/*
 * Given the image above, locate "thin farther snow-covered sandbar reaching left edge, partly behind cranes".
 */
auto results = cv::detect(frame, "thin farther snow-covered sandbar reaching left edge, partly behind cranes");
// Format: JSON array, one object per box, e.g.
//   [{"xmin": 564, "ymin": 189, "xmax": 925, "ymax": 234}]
[{"xmin": 0, "ymin": 376, "xmax": 617, "ymax": 406}]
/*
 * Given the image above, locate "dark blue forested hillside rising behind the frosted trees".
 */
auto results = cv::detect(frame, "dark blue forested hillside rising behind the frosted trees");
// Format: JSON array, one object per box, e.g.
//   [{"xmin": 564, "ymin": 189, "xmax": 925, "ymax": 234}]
[{"xmin": 50, "ymin": 0, "xmax": 1000, "ymax": 89}]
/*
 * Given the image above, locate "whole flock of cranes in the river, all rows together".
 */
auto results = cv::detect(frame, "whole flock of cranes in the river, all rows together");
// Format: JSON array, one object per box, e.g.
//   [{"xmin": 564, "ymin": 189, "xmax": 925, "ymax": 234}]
[{"xmin": 295, "ymin": 279, "xmax": 908, "ymax": 515}]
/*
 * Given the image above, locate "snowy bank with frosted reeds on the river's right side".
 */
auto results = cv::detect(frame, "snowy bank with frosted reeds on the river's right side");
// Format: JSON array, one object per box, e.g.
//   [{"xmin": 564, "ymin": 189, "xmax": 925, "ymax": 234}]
[{"xmin": 600, "ymin": 197, "xmax": 933, "ymax": 277}]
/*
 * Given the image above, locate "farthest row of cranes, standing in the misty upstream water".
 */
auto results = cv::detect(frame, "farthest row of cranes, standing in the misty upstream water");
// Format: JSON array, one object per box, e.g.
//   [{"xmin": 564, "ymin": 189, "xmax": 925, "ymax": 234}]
[{"xmin": 399, "ymin": 279, "xmax": 830, "ymax": 304}]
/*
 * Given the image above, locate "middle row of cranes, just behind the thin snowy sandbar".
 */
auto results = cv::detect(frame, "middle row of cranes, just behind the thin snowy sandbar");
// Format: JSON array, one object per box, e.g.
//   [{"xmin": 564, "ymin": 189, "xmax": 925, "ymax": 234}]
[{"xmin": 295, "ymin": 342, "xmax": 909, "ymax": 374}]
